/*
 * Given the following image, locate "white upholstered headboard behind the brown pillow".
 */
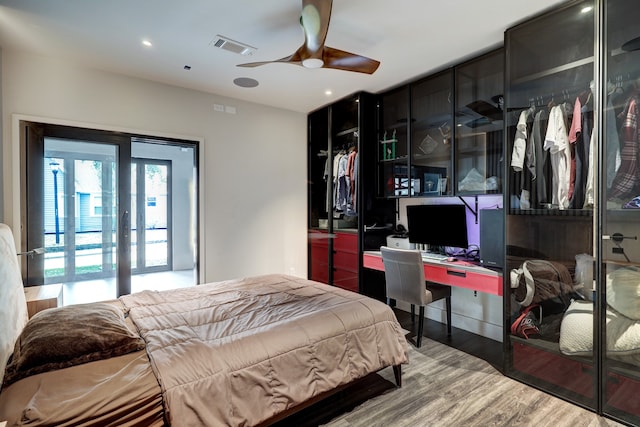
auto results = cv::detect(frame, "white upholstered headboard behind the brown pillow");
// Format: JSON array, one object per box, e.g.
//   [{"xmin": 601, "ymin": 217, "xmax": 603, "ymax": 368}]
[{"xmin": 0, "ymin": 223, "xmax": 29, "ymax": 387}]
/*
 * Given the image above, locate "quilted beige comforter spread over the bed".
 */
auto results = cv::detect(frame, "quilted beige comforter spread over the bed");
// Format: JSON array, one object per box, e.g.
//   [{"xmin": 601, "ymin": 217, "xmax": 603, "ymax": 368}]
[{"xmin": 121, "ymin": 275, "xmax": 407, "ymax": 426}]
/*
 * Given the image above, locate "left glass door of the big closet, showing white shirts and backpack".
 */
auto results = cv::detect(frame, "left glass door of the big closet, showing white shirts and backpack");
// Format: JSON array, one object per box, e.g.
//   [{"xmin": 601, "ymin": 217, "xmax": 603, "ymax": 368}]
[{"xmin": 504, "ymin": 1, "xmax": 598, "ymax": 410}]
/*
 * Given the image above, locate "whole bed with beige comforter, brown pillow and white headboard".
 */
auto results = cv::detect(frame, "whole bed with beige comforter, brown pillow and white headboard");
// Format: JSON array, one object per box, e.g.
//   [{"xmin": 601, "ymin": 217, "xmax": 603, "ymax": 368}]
[{"xmin": 0, "ymin": 224, "xmax": 408, "ymax": 426}]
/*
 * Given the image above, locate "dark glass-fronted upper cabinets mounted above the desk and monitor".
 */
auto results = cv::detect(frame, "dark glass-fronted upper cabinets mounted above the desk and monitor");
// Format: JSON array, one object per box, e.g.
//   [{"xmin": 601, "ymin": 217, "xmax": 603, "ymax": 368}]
[{"xmin": 378, "ymin": 49, "xmax": 504, "ymax": 198}]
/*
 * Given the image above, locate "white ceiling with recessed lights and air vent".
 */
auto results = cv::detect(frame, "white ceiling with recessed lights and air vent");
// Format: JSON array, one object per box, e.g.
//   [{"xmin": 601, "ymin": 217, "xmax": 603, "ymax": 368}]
[{"xmin": 0, "ymin": 0, "xmax": 566, "ymax": 113}]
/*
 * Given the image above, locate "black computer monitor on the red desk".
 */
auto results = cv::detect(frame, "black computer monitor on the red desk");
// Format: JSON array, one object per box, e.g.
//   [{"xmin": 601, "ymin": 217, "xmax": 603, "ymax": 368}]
[{"xmin": 407, "ymin": 205, "xmax": 469, "ymax": 250}]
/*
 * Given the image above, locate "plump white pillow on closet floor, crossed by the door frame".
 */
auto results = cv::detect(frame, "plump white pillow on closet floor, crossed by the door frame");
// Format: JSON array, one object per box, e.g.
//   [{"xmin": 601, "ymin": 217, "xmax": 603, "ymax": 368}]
[{"xmin": 560, "ymin": 301, "xmax": 640, "ymax": 356}]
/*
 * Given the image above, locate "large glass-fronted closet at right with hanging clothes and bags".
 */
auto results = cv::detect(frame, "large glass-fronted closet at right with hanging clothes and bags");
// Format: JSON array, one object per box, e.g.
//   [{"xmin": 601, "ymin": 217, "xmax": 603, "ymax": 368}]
[{"xmin": 504, "ymin": 0, "xmax": 640, "ymax": 425}]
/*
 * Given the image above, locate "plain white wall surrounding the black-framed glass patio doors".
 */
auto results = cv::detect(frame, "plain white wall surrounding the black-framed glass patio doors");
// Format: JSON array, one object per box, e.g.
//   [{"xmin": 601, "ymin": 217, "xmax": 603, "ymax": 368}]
[{"xmin": 0, "ymin": 49, "xmax": 307, "ymax": 281}]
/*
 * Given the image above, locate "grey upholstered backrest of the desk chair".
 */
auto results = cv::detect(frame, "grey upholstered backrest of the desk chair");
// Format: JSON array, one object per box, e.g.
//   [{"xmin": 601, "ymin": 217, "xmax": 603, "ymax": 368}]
[{"xmin": 380, "ymin": 246, "xmax": 430, "ymax": 305}]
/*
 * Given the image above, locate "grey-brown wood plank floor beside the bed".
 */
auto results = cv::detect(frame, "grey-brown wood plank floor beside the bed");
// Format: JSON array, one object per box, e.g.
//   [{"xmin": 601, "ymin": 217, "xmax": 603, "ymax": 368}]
[{"xmin": 277, "ymin": 312, "xmax": 622, "ymax": 427}]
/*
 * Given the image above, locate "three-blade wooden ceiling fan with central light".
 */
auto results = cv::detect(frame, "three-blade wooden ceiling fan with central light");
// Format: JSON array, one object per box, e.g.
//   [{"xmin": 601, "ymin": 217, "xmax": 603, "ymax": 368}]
[{"xmin": 238, "ymin": 0, "xmax": 380, "ymax": 74}]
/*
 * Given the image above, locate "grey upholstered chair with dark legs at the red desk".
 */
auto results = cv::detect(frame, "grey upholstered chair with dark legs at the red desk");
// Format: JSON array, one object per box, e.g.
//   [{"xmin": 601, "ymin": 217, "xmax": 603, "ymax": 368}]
[{"xmin": 380, "ymin": 246, "xmax": 451, "ymax": 347}]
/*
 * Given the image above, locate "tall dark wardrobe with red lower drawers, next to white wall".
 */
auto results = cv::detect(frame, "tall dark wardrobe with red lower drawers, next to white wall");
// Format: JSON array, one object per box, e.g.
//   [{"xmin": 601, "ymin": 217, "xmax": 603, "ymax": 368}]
[{"xmin": 308, "ymin": 92, "xmax": 393, "ymax": 292}]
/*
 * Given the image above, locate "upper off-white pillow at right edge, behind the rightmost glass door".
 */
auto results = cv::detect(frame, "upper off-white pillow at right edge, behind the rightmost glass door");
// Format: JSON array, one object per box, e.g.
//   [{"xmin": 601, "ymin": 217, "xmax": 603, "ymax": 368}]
[{"xmin": 607, "ymin": 267, "xmax": 640, "ymax": 320}]
